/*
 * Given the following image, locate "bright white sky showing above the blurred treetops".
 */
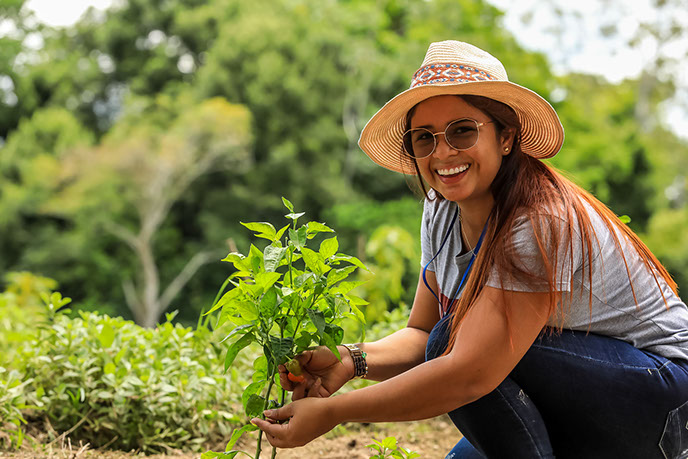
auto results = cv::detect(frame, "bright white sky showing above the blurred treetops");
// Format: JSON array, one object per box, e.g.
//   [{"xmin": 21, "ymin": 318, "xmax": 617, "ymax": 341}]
[{"xmin": 20, "ymin": 0, "xmax": 688, "ymax": 138}]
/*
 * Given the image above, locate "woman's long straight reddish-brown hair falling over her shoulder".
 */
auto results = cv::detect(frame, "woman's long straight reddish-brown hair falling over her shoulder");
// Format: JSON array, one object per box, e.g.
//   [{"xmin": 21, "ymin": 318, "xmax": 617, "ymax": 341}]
[{"xmin": 407, "ymin": 96, "xmax": 677, "ymax": 353}]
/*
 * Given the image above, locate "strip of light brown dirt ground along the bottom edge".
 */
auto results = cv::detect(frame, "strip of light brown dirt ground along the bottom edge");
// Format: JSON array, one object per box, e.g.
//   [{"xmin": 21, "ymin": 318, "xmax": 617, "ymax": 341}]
[{"xmin": 0, "ymin": 416, "xmax": 461, "ymax": 459}]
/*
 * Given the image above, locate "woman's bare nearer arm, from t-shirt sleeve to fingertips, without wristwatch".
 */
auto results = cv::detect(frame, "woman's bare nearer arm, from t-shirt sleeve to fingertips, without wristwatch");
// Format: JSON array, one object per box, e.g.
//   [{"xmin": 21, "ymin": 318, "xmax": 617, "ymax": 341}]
[{"xmin": 254, "ymin": 287, "xmax": 549, "ymax": 448}]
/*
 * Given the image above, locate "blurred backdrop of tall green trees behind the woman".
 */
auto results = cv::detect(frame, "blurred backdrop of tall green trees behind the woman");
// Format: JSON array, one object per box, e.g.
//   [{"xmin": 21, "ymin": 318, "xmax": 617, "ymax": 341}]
[{"xmin": 0, "ymin": 0, "xmax": 688, "ymax": 325}]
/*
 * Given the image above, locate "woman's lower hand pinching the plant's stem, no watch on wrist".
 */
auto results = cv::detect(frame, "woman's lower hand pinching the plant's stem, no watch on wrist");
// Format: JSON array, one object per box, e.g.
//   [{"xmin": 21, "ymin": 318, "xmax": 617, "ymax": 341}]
[{"xmin": 251, "ymin": 397, "xmax": 337, "ymax": 448}]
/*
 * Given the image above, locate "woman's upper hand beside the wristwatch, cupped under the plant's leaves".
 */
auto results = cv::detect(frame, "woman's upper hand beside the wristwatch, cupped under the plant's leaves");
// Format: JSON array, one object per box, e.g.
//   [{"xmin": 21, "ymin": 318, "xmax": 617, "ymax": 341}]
[{"xmin": 278, "ymin": 346, "xmax": 354, "ymax": 400}]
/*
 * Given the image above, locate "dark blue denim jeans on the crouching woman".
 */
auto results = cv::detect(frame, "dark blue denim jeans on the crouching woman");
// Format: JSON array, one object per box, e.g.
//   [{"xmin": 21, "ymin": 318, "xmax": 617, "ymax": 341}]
[{"xmin": 426, "ymin": 317, "xmax": 688, "ymax": 459}]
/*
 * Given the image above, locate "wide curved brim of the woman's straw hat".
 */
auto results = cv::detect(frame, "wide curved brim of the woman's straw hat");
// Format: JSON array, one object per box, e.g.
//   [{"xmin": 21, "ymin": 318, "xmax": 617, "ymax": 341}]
[{"xmin": 358, "ymin": 81, "xmax": 564, "ymax": 175}]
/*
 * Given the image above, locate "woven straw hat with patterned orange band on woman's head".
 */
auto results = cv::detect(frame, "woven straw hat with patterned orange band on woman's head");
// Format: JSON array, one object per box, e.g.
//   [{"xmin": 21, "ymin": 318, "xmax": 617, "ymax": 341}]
[{"xmin": 358, "ymin": 40, "xmax": 564, "ymax": 174}]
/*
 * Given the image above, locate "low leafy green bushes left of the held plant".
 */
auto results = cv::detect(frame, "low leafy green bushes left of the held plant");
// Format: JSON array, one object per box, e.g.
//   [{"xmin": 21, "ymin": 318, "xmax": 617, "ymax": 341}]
[{"xmin": 0, "ymin": 273, "xmax": 250, "ymax": 453}]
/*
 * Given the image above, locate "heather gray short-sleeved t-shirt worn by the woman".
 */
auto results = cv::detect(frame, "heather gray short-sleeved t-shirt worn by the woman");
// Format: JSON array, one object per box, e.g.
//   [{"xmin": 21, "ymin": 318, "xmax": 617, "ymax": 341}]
[{"xmin": 421, "ymin": 194, "xmax": 688, "ymax": 360}]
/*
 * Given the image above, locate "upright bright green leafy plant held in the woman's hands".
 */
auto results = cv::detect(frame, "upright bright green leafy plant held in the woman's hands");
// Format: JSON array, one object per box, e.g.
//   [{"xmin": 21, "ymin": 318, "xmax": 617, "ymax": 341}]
[{"xmin": 204, "ymin": 198, "xmax": 365, "ymax": 459}]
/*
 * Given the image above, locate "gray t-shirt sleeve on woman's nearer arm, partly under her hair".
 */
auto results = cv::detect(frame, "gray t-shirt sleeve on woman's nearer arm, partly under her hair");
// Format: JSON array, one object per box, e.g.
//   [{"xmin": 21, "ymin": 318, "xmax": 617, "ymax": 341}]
[{"xmin": 486, "ymin": 215, "xmax": 582, "ymax": 292}]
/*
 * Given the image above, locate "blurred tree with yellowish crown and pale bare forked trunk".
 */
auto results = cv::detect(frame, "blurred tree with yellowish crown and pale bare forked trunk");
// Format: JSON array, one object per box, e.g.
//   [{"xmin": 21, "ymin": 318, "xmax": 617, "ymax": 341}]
[{"xmin": 52, "ymin": 98, "xmax": 251, "ymax": 327}]
